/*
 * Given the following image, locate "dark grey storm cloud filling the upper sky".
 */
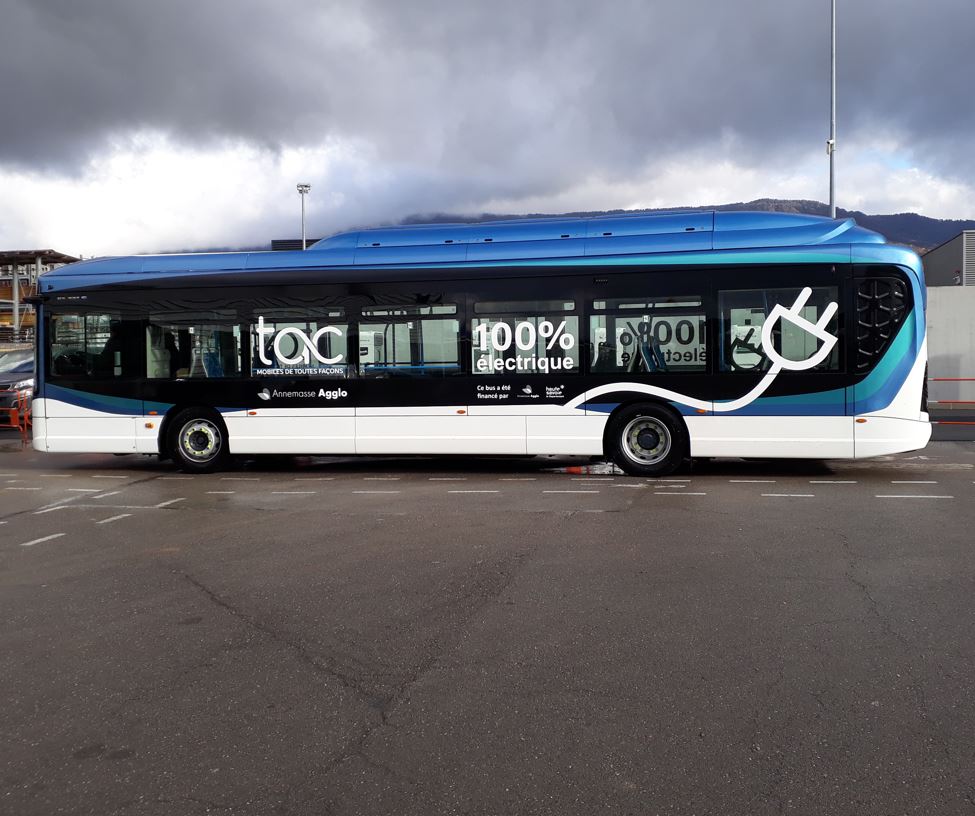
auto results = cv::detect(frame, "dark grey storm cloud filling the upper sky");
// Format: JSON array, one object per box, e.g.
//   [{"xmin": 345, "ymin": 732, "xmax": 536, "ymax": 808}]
[{"xmin": 0, "ymin": 0, "xmax": 975, "ymax": 186}]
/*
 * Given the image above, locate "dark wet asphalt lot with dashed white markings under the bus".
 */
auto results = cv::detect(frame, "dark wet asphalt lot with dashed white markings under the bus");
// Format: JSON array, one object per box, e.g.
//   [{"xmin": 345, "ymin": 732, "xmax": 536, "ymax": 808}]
[{"xmin": 0, "ymin": 437, "xmax": 975, "ymax": 816}]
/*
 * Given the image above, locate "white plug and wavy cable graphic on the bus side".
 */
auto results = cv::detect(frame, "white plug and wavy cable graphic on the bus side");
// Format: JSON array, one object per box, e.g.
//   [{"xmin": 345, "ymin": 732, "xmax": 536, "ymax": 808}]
[{"xmin": 565, "ymin": 286, "xmax": 839, "ymax": 413}]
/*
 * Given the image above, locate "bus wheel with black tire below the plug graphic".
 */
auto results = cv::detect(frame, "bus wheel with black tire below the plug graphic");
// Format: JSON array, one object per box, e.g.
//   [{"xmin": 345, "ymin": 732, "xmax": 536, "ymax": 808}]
[{"xmin": 606, "ymin": 403, "xmax": 688, "ymax": 476}]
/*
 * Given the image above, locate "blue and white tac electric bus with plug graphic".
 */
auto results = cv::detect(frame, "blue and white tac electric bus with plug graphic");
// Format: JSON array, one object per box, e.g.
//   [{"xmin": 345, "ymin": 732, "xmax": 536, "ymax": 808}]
[{"xmin": 28, "ymin": 212, "xmax": 930, "ymax": 476}]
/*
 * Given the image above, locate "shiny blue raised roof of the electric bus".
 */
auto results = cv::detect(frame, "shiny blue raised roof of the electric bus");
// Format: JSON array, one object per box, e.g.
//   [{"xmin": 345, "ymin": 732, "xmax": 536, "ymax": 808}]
[{"xmin": 40, "ymin": 211, "xmax": 920, "ymax": 294}]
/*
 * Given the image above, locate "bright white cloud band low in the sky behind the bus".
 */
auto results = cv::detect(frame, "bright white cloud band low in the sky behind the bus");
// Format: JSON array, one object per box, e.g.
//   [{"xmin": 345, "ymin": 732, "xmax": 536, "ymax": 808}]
[{"xmin": 0, "ymin": 132, "xmax": 975, "ymax": 256}]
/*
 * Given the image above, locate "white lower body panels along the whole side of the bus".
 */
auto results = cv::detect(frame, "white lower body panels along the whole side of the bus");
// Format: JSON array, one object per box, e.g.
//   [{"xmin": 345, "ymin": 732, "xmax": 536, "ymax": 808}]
[{"xmin": 33, "ymin": 399, "xmax": 931, "ymax": 466}]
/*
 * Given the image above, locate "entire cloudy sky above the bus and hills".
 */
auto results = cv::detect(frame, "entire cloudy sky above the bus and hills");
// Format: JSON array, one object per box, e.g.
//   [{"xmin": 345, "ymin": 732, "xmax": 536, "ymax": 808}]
[{"xmin": 0, "ymin": 0, "xmax": 975, "ymax": 256}]
